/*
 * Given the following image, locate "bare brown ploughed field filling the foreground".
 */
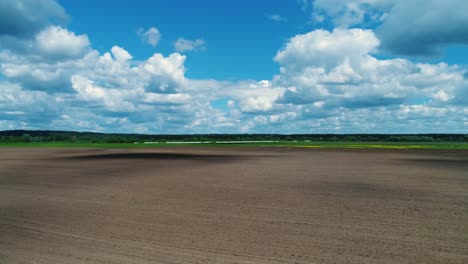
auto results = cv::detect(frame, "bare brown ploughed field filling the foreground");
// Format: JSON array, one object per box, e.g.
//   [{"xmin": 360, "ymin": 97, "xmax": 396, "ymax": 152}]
[{"xmin": 0, "ymin": 147, "xmax": 468, "ymax": 264}]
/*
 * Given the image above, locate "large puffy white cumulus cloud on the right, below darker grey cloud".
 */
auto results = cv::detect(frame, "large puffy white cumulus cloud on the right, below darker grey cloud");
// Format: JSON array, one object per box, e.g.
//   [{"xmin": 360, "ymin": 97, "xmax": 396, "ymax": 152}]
[{"xmin": 273, "ymin": 29, "xmax": 467, "ymax": 112}]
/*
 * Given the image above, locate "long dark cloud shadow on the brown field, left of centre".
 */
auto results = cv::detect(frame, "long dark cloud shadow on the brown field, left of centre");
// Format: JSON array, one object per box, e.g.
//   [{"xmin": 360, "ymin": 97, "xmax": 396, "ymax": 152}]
[{"xmin": 61, "ymin": 153, "xmax": 249, "ymax": 161}]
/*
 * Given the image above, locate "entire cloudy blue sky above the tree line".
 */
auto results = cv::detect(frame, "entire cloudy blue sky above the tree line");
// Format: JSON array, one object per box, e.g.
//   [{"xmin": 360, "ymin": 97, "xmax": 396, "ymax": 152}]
[{"xmin": 0, "ymin": 0, "xmax": 468, "ymax": 134}]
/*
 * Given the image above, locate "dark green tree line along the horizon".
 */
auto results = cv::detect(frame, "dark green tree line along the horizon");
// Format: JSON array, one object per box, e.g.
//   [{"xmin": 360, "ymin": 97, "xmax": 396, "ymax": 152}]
[{"xmin": 0, "ymin": 130, "xmax": 468, "ymax": 143}]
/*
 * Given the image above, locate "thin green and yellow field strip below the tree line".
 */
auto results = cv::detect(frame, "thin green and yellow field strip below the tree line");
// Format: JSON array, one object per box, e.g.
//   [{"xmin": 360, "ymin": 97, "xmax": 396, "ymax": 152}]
[{"xmin": 0, "ymin": 141, "xmax": 468, "ymax": 149}]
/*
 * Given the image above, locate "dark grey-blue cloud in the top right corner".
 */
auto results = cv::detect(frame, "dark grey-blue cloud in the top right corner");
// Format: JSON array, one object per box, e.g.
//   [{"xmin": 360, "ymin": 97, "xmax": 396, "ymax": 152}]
[{"xmin": 311, "ymin": 0, "xmax": 468, "ymax": 56}]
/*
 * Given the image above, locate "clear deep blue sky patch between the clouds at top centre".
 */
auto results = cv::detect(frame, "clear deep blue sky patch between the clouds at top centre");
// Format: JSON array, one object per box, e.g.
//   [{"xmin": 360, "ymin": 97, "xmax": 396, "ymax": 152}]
[{"xmin": 61, "ymin": 0, "xmax": 311, "ymax": 80}]
